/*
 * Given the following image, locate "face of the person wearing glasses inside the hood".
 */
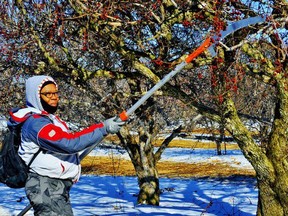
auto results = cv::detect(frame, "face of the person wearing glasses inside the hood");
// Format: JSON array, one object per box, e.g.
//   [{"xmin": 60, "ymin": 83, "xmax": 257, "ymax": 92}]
[{"xmin": 40, "ymin": 83, "xmax": 59, "ymax": 107}]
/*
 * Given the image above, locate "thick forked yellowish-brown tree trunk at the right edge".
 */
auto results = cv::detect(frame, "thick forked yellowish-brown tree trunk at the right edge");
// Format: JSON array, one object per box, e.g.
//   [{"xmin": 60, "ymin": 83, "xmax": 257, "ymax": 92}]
[{"xmin": 226, "ymin": 96, "xmax": 288, "ymax": 216}]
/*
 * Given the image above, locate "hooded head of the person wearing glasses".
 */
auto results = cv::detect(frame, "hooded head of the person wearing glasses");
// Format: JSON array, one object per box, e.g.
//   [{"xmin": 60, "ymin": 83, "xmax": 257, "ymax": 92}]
[{"xmin": 26, "ymin": 75, "xmax": 59, "ymax": 114}]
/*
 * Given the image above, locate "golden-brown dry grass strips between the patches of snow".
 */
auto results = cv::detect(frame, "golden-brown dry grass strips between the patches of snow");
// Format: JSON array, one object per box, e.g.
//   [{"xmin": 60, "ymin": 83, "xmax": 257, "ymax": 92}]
[{"xmin": 82, "ymin": 140, "xmax": 255, "ymax": 178}]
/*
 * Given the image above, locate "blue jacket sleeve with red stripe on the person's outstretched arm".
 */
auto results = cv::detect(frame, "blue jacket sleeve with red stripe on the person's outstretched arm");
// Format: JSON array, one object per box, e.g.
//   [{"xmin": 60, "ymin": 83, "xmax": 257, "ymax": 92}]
[{"xmin": 22, "ymin": 117, "xmax": 107, "ymax": 154}]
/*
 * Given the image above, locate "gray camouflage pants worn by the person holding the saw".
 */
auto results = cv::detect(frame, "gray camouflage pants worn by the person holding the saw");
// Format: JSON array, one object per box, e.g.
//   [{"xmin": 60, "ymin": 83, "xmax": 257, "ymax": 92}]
[{"xmin": 25, "ymin": 173, "xmax": 73, "ymax": 216}]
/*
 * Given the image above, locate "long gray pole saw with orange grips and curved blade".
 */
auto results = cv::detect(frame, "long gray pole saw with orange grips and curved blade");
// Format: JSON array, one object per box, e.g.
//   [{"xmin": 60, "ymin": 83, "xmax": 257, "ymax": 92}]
[{"xmin": 17, "ymin": 16, "xmax": 266, "ymax": 216}]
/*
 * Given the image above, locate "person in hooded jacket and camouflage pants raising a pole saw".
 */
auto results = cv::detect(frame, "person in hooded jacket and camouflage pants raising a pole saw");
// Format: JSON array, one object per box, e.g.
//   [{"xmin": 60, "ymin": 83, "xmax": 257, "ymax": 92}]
[{"xmin": 8, "ymin": 75, "xmax": 125, "ymax": 216}]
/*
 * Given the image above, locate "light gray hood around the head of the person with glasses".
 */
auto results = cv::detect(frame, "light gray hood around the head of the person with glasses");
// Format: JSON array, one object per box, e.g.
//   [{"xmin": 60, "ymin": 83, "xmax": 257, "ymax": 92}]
[{"xmin": 26, "ymin": 75, "xmax": 57, "ymax": 111}]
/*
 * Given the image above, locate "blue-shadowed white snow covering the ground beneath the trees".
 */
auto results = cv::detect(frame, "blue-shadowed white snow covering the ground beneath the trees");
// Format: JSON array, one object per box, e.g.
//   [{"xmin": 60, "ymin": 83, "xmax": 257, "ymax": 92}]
[{"xmin": 0, "ymin": 142, "xmax": 258, "ymax": 216}]
